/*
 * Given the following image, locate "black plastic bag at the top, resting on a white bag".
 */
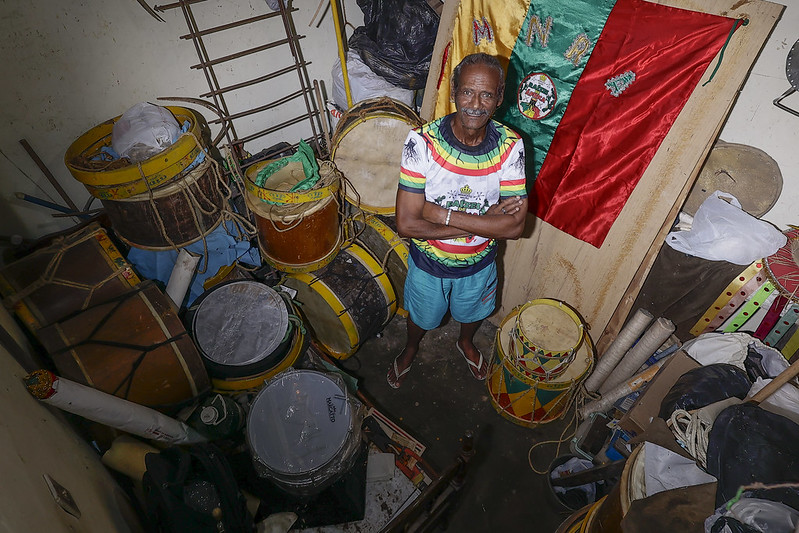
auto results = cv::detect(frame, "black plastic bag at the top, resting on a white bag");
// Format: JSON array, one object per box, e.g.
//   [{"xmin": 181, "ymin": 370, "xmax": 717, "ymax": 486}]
[{"xmin": 348, "ymin": 0, "xmax": 439, "ymax": 90}]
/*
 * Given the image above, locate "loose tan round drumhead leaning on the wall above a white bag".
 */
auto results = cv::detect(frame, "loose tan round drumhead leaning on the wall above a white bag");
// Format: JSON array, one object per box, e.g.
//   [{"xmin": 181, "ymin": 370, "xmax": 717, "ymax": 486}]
[{"xmin": 682, "ymin": 141, "xmax": 782, "ymax": 217}]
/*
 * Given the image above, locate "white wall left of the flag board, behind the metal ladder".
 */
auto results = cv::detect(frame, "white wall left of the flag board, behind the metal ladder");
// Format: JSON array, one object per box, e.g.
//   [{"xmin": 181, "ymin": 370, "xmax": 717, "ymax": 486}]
[{"xmin": 0, "ymin": 0, "xmax": 363, "ymax": 238}]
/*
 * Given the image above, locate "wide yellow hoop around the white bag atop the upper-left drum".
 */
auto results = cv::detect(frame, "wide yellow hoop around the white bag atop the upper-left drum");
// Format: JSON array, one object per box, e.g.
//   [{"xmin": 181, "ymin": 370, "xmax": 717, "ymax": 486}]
[{"xmin": 64, "ymin": 106, "xmax": 208, "ymax": 200}]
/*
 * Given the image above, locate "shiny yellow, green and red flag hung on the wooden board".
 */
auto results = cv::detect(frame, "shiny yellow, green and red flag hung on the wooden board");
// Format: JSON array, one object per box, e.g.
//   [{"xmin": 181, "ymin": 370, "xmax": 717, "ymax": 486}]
[{"xmin": 435, "ymin": 0, "xmax": 740, "ymax": 247}]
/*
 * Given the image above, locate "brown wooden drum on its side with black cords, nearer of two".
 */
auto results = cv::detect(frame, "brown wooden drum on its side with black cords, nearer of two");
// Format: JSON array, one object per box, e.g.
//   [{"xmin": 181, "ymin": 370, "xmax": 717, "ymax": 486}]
[{"xmin": 39, "ymin": 281, "xmax": 211, "ymax": 410}]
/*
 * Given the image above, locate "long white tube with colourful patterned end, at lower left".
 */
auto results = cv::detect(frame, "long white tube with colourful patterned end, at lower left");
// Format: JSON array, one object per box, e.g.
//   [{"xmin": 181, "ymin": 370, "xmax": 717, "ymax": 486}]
[{"xmin": 25, "ymin": 370, "xmax": 207, "ymax": 444}]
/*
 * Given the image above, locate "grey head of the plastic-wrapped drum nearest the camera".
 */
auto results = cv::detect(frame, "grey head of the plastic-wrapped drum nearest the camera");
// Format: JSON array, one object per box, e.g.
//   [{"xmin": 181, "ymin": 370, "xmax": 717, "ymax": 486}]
[{"xmin": 247, "ymin": 370, "xmax": 353, "ymax": 476}]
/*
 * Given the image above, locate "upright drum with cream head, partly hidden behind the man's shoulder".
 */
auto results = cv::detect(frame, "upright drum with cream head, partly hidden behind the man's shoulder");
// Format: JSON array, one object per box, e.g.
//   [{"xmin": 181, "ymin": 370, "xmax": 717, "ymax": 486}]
[{"xmin": 330, "ymin": 97, "xmax": 423, "ymax": 215}]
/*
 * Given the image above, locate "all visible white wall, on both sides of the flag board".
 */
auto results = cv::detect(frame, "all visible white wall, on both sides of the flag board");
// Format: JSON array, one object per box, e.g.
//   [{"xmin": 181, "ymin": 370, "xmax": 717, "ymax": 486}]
[{"xmin": 0, "ymin": 0, "xmax": 799, "ymax": 237}]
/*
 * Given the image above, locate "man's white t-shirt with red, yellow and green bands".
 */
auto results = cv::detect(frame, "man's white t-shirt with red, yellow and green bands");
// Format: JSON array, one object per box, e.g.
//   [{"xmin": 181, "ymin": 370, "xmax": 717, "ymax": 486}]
[{"xmin": 399, "ymin": 115, "xmax": 527, "ymax": 278}]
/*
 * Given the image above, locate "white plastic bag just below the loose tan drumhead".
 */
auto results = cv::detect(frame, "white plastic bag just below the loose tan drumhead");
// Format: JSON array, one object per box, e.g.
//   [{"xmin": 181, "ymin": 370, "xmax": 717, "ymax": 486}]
[{"xmin": 666, "ymin": 191, "xmax": 787, "ymax": 265}]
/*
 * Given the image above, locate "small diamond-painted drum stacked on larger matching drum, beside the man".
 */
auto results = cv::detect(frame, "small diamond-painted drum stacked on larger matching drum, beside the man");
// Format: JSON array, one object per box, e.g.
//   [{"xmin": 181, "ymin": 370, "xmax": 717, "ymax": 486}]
[{"xmin": 486, "ymin": 298, "xmax": 594, "ymax": 427}]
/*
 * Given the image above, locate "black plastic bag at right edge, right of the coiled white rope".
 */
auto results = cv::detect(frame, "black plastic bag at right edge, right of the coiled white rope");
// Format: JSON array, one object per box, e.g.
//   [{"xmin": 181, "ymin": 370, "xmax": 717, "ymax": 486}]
[{"xmin": 707, "ymin": 402, "xmax": 799, "ymax": 509}]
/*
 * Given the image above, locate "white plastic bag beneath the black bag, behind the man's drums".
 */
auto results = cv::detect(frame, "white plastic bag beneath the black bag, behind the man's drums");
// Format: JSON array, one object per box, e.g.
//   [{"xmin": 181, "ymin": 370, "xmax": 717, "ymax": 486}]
[{"xmin": 331, "ymin": 50, "xmax": 414, "ymax": 110}]
